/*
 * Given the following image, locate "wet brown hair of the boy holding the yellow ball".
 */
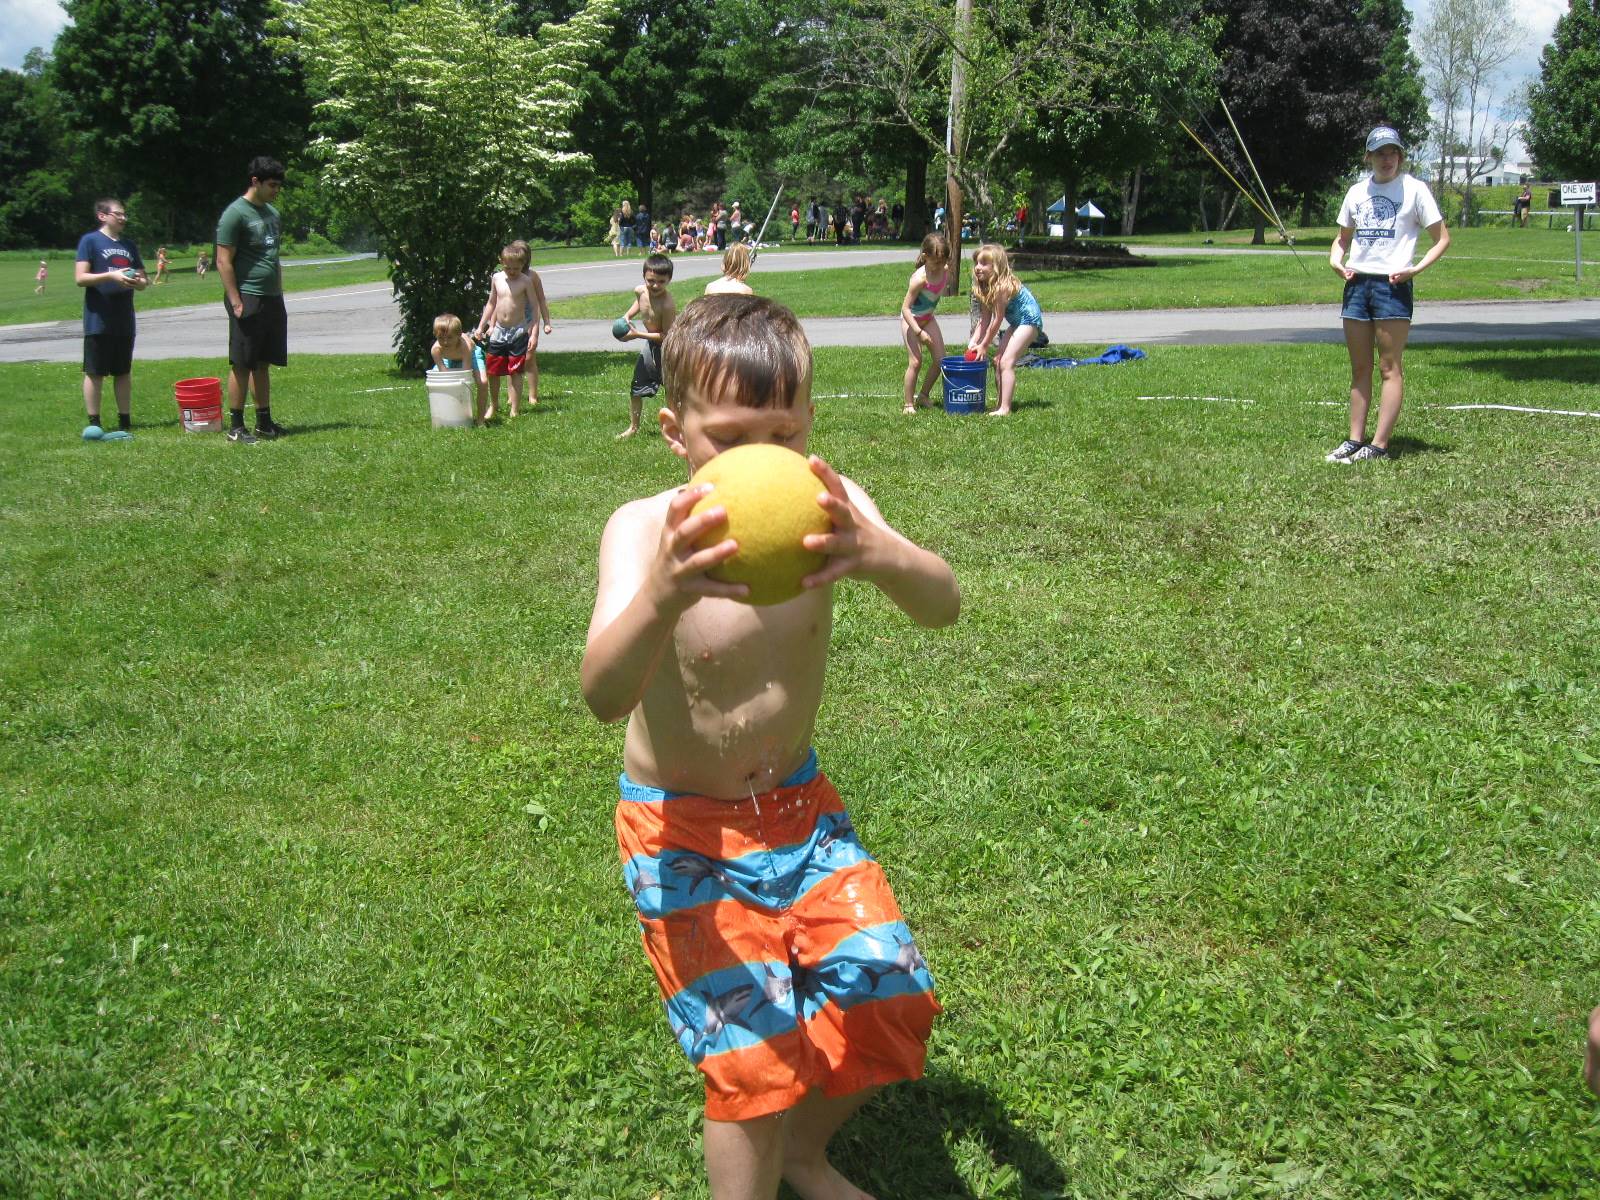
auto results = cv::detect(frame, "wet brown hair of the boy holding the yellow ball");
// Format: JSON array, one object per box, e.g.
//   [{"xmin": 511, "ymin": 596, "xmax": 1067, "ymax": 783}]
[{"xmin": 661, "ymin": 296, "xmax": 811, "ymax": 413}]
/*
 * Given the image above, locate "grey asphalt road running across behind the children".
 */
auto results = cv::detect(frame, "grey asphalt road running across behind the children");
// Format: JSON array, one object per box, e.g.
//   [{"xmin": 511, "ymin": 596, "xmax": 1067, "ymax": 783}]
[{"xmin": 0, "ymin": 246, "xmax": 1600, "ymax": 362}]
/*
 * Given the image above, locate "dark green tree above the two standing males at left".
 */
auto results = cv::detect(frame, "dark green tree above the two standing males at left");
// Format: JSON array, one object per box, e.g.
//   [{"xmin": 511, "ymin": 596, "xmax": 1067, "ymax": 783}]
[{"xmin": 53, "ymin": 0, "xmax": 309, "ymax": 237}]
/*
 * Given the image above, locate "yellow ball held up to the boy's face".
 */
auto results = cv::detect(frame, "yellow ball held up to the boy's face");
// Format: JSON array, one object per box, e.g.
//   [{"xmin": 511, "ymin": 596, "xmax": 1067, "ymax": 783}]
[{"xmin": 690, "ymin": 443, "xmax": 834, "ymax": 605}]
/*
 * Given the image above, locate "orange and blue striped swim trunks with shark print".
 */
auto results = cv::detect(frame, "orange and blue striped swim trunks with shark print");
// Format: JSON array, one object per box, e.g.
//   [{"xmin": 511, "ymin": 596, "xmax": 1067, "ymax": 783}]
[{"xmin": 616, "ymin": 750, "xmax": 939, "ymax": 1122}]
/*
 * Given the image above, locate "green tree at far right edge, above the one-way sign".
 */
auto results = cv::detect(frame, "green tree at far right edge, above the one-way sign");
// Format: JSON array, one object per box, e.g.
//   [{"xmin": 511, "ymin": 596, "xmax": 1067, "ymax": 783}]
[{"xmin": 1528, "ymin": 0, "xmax": 1600, "ymax": 181}]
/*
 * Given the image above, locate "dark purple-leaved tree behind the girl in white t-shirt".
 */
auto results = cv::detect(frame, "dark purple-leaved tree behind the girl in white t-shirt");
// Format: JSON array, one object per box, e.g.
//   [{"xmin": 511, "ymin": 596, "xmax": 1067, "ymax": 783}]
[{"xmin": 1208, "ymin": 0, "xmax": 1416, "ymax": 243}]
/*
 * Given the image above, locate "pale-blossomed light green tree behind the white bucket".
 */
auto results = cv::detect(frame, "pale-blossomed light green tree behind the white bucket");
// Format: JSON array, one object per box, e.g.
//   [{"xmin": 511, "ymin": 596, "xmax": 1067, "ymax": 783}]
[{"xmin": 290, "ymin": 0, "xmax": 614, "ymax": 368}]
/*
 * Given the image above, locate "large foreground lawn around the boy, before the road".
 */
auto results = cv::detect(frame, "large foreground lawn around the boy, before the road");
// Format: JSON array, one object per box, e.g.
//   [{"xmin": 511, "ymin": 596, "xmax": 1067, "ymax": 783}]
[{"xmin": 0, "ymin": 342, "xmax": 1600, "ymax": 1200}]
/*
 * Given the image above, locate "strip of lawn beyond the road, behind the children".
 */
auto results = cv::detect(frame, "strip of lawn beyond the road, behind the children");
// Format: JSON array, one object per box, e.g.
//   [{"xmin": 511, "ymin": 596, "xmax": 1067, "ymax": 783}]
[{"xmin": 550, "ymin": 229, "xmax": 1600, "ymax": 320}]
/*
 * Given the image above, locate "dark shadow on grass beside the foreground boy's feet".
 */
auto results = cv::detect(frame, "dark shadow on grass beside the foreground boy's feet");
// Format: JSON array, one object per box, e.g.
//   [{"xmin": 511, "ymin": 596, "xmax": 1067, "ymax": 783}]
[{"xmin": 825, "ymin": 1074, "xmax": 1067, "ymax": 1200}]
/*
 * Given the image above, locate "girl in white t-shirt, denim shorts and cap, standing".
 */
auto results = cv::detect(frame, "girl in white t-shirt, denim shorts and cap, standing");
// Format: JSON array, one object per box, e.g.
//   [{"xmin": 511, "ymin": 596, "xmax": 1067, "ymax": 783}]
[{"xmin": 1328, "ymin": 125, "xmax": 1450, "ymax": 462}]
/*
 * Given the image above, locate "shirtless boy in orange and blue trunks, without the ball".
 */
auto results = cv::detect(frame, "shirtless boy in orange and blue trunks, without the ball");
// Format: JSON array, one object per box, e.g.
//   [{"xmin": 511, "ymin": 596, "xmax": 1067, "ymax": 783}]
[{"xmin": 582, "ymin": 296, "xmax": 962, "ymax": 1200}]
